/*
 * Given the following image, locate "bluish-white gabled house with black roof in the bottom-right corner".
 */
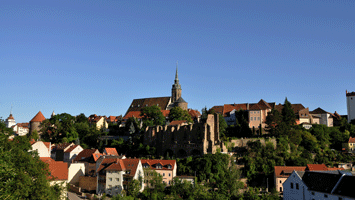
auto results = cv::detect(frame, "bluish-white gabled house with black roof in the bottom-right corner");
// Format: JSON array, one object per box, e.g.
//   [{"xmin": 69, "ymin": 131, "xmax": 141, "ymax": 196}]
[{"xmin": 283, "ymin": 170, "xmax": 355, "ymax": 200}]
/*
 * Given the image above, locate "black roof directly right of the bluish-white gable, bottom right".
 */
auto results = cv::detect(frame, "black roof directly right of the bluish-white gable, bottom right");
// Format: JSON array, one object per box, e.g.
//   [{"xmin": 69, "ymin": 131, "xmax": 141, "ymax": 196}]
[{"xmin": 302, "ymin": 171, "xmax": 342, "ymax": 193}]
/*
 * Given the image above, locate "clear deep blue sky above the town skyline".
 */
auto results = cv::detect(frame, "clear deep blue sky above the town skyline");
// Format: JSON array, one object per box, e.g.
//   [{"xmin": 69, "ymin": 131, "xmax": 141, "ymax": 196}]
[{"xmin": 0, "ymin": 0, "xmax": 355, "ymax": 122}]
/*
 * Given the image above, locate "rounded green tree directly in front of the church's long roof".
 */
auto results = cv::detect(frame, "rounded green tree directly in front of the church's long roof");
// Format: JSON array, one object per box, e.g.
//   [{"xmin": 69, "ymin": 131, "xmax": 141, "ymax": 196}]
[{"xmin": 140, "ymin": 105, "xmax": 165, "ymax": 128}]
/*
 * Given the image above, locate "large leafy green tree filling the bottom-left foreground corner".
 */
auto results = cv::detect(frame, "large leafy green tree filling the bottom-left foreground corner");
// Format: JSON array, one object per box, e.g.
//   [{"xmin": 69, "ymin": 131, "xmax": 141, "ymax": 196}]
[{"xmin": 0, "ymin": 123, "xmax": 62, "ymax": 199}]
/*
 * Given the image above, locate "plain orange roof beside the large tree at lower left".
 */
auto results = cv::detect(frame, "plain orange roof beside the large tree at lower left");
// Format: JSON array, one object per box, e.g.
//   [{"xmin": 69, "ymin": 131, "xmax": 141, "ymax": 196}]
[{"xmin": 40, "ymin": 157, "xmax": 68, "ymax": 180}]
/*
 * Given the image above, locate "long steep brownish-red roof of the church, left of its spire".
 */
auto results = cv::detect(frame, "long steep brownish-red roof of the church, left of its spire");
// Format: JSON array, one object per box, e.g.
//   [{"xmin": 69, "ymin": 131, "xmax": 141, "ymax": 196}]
[{"xmin": 126, "ymin": 97, "xmax": 171, "ymax": 115}]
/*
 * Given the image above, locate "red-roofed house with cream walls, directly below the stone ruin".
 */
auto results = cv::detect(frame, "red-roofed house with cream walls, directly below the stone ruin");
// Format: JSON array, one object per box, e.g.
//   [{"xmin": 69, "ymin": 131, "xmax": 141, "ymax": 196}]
[{"xmin": 142, "ymin": 159, "xmax": 177, "ymax": 187}]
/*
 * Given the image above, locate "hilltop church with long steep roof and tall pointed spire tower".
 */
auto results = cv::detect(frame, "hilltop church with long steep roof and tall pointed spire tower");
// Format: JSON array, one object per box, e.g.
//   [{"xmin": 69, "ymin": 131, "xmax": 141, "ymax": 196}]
[{"xmin": 124, "ymin": 67, "xmax": 188, "ymax": 119}]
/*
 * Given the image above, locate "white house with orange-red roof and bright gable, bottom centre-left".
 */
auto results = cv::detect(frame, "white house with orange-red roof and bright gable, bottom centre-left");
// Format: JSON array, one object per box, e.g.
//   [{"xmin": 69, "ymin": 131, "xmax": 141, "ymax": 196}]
[{"xmin": 96, "ymin": 156, "xmax": 144, "ymax": 196}]
